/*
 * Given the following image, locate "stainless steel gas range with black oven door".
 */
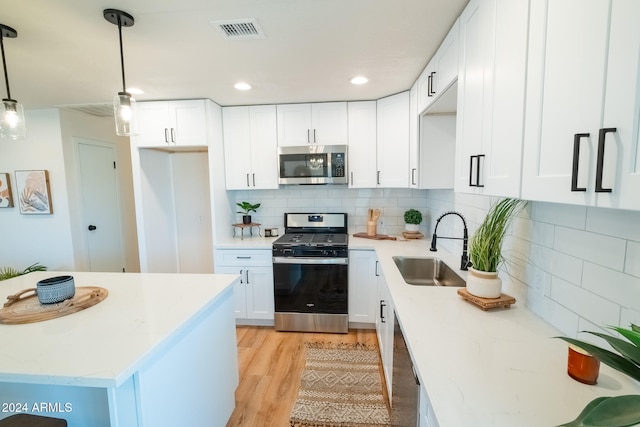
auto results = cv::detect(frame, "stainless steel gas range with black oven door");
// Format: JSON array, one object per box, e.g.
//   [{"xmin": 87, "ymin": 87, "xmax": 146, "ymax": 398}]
[{"xmin": 273, "ymin": 213, "xmax": 349, "ymax": 333}]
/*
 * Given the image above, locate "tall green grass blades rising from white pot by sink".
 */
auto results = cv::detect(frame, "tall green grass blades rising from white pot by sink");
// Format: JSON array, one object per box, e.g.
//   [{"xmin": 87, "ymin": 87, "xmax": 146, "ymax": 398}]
[{"xmin": 469, "ymin": 198, "xmax": 527, "ymax": 273}]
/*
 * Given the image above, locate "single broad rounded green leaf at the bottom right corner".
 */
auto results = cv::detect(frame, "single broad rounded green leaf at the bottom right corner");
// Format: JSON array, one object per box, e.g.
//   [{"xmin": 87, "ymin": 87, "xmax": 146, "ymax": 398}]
[{"xmin": 581, "ymin": 394, "xmax": 640, "ymax": 427}]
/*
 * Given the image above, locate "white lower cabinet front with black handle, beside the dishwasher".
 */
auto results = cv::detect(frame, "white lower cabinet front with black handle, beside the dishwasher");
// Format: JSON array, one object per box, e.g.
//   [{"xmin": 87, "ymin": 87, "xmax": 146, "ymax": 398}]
[{"xmin": 376, "ymin": 271, "xmax": 395, "ymax": 401}]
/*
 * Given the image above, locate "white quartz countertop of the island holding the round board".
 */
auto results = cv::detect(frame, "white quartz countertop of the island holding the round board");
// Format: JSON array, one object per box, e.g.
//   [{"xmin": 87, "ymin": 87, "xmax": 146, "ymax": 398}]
[{"xmin": 0, "ymin": 271, "xmax": 238, "ymax": 387}]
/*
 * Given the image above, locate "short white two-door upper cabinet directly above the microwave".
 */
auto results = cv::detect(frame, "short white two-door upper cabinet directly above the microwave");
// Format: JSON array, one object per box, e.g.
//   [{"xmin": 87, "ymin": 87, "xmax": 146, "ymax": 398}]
[{"xmin": 277, "ymin": 102, "xmax": 348, "ymax": 146}]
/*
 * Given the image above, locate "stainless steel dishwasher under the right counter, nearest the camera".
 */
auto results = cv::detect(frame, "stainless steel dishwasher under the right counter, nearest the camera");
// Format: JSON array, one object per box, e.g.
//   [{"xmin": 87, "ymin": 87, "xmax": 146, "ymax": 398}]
[{"xmin": 391, "ymin": 313, "xmax": 420, "ymax": 427}]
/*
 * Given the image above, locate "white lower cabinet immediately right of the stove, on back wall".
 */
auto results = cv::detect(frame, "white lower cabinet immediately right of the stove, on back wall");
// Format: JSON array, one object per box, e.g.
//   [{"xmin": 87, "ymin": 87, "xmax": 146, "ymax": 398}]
[{"xmin": 349, "ymin": 250, "xmax": 378, "ymax": 325}]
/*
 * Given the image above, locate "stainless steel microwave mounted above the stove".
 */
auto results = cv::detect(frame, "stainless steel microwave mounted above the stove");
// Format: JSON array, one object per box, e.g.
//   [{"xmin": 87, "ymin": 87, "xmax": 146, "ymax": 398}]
[{"xmin": 278, "ymin": 145, "xmax": 348, "ymax": 184}]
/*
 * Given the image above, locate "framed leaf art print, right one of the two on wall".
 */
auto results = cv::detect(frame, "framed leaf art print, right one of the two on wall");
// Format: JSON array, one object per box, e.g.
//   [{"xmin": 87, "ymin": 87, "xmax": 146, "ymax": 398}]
[{"xmin": 16, "ymin": 170, "xmax": 53, "ymax": 215}]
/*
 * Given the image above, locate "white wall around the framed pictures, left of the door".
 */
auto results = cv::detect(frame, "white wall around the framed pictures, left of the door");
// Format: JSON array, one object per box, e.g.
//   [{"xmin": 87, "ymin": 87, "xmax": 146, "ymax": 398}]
[{"xmin": 0, "ymin": 109, "xmax": 75, "ymax": 270}]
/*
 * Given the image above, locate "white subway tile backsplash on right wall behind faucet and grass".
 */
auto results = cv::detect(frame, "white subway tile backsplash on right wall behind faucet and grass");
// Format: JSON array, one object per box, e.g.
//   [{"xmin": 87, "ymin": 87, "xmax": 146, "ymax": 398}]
[{"xmin": 427, "ymin": 190, "xmax": 640, "ymax": 337}]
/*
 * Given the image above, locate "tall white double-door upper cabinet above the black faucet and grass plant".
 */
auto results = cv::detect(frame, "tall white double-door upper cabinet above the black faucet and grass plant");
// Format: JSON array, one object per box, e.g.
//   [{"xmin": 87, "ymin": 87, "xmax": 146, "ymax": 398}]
[{"xmin": 454, "ymin": 0, "xmax": 529, "ymax": 197}]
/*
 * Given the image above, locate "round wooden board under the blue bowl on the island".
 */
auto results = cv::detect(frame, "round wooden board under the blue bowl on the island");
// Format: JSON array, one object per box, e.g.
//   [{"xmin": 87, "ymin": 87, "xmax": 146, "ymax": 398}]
[{"xmin": 0, "ymin": 286, "xmax": 109, "ymax": 325}]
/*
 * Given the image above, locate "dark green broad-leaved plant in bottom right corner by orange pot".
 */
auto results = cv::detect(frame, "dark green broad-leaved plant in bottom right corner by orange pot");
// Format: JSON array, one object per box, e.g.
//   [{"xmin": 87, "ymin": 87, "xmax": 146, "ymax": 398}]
[{"xmin": 556, "ymin": 325, "xmax": 640, "ymax": 427}]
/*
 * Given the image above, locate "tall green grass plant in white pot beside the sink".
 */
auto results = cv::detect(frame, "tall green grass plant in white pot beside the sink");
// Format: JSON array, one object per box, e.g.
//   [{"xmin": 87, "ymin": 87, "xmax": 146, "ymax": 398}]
[{"xmin": 467, "ymin": 198, "xmax": 526, "ymax": 298}]
